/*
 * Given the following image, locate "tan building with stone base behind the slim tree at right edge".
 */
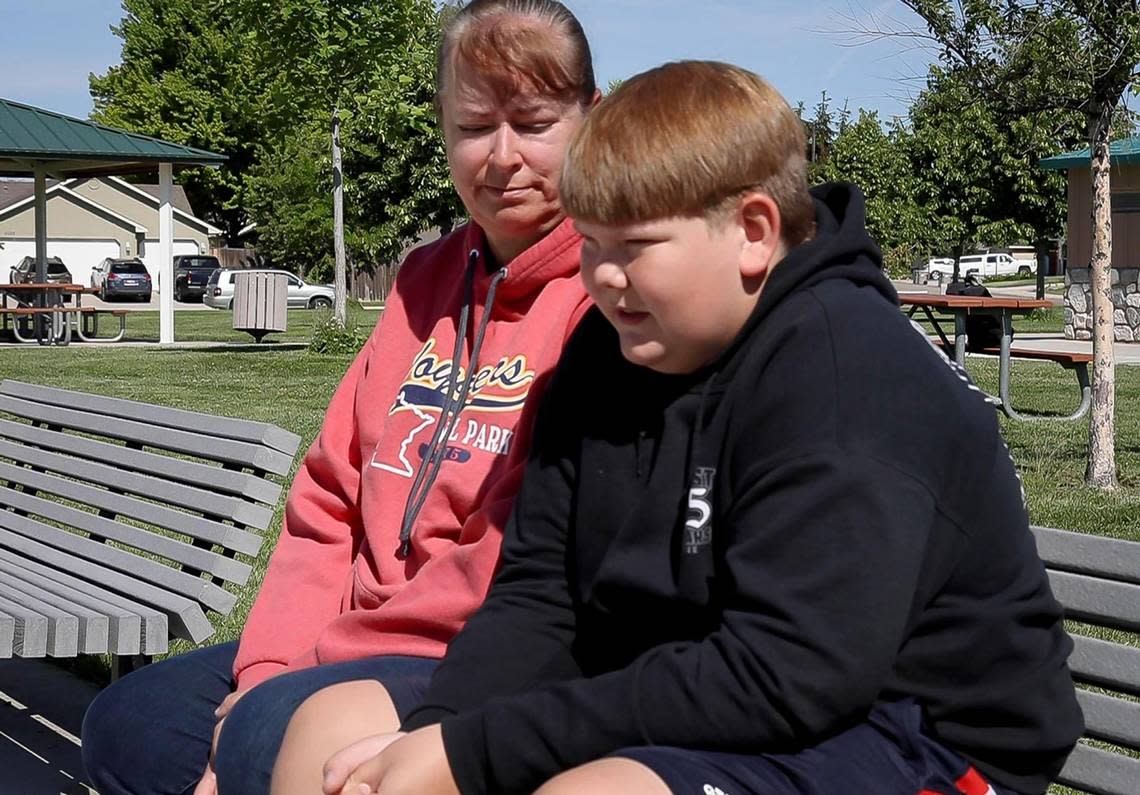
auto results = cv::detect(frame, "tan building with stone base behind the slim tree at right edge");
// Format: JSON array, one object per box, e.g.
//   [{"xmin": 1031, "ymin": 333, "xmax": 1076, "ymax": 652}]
[{"xmin": 1041, "ymin": 136, "xmax": 1140, "ymax": 342}]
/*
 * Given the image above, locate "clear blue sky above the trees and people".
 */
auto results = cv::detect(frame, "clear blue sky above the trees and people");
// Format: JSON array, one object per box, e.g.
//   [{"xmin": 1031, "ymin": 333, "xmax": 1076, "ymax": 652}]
[{"xmin": 0, "ymin": 0, "xmax": 935, "ymax": 117}]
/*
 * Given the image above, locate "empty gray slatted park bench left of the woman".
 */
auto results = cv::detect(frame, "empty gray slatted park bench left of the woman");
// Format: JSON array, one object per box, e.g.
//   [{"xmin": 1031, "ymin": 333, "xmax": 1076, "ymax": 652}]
[{"xmin": 0, "ymin": 381, "xmax": 301, "ymax": 676}]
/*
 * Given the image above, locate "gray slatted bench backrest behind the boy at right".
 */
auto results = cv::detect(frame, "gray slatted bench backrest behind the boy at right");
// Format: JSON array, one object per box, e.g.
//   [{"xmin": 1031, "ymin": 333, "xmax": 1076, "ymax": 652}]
[{"xmin": 1033, "ymin": 527, "xmax": 1140, "ymax": 795}]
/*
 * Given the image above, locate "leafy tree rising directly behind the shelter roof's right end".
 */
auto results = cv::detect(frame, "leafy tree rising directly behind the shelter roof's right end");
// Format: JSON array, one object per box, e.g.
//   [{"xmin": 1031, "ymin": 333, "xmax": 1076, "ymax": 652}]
[{"xmin": 89, "ymin": 0, "xmax": 266, "ymax": 241}]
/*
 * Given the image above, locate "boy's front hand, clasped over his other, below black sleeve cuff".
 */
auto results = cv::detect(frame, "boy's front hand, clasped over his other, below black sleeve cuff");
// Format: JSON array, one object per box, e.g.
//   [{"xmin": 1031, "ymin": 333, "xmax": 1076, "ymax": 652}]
[{"xmin": 341, "ymin": 723, "xmax": 459, "ymax": 795}]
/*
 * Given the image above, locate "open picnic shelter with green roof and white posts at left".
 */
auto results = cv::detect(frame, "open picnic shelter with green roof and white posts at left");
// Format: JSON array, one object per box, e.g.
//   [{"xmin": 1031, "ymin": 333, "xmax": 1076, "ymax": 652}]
[{"xmin": 0, "ymin": 99, "xmax": 226, "ymax": 344}]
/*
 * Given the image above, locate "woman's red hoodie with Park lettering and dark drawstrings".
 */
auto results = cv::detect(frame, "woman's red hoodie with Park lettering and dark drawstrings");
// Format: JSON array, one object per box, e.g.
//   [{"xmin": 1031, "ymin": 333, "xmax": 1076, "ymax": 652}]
[{"xmin": 234, "ymin": 220, "xmax": 588, "ymax": 689}]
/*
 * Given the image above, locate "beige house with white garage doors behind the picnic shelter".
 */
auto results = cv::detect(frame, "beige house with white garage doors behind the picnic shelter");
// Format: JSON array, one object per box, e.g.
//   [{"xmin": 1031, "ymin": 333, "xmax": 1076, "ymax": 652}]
[{"xmin": 0, "ymin": 177, "xmax": 222, "ymax": 284}]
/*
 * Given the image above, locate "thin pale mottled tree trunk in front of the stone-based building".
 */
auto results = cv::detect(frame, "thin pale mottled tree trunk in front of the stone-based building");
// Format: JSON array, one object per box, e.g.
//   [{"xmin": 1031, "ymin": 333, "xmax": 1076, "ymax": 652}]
[{"xmin": 1084, "ymin": 103, "xmax": 1117, "ymax": 489}]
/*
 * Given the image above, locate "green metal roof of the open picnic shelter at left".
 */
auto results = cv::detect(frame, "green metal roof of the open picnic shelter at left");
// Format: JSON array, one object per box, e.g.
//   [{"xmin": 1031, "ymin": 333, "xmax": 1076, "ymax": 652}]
[{"xmin": 0, "ymin": 99, "xmax": 226, "ymax": 177}]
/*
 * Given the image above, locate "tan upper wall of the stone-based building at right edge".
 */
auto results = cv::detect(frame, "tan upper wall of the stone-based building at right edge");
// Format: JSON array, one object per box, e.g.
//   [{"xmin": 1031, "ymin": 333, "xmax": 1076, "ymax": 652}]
[{"xmin": 1068, "ymin": 165, "xmax": 1140, "ymax": 269}]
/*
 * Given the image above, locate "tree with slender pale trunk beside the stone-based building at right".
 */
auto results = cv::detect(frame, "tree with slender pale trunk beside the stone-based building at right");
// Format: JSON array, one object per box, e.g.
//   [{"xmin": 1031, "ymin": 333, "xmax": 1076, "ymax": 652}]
[{"xmin": 903, "ymin": 0, "xmax": 1140, "ymax": 489}]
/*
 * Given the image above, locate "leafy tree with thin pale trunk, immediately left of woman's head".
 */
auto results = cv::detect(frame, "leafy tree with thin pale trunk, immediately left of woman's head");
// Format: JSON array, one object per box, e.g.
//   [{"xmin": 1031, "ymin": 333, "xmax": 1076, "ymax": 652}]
[{"xmin": 243, "ymin": 2, "xmax": 463, "ymax": 296}]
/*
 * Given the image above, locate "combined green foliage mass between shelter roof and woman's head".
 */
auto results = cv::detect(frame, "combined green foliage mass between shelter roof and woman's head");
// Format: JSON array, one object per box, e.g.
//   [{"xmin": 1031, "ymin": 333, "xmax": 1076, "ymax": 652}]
[{"xmin": 90, "ymin": 0, "xmax": 462, "ymax": 284}]
